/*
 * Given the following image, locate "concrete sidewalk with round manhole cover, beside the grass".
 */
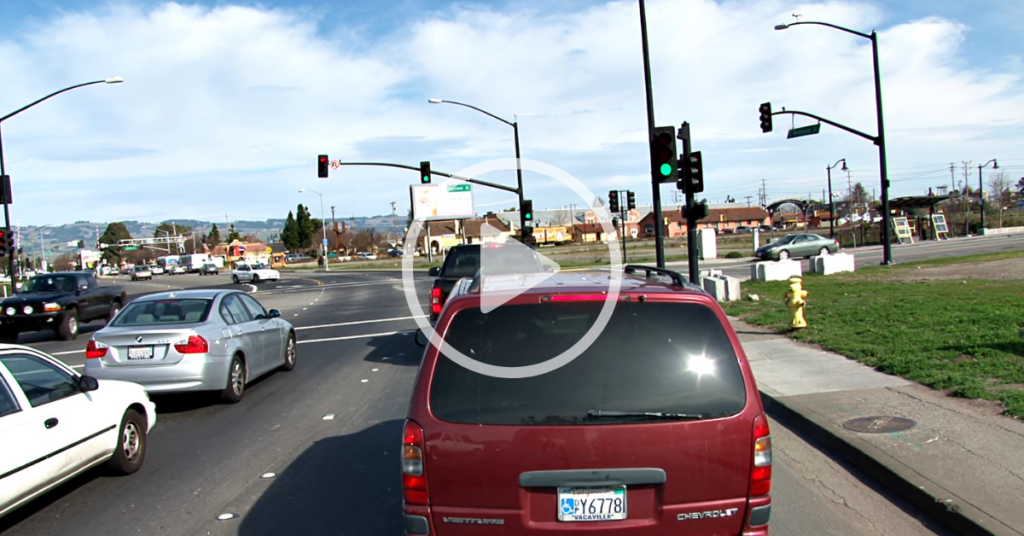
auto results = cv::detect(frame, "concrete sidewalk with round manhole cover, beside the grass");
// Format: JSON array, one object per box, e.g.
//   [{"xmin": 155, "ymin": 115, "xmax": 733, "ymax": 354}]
[{"xmin": 730, "ymin": 318, "xmax": 1024, "ymax": 536}]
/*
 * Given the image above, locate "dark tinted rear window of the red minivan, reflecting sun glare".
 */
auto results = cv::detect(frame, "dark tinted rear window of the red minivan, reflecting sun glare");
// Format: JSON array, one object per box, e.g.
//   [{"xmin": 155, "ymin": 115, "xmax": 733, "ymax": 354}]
[{"xmin": 429, "ymin": 301, "xmax": 746, "ymax": 425}]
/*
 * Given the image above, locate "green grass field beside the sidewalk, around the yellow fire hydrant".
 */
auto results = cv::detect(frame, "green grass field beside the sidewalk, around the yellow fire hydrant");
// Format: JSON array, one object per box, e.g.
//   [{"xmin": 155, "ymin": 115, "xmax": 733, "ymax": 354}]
[{"xmin": 725, "ymin": 264, "xmax": 1024, "ymax": 417}]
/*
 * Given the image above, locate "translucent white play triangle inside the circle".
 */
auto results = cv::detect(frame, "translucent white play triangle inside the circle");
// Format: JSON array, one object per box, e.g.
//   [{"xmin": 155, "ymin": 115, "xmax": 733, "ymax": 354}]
[{"xmin": 480, "ymin": 222, "xmax": 560, "ymax": 315}]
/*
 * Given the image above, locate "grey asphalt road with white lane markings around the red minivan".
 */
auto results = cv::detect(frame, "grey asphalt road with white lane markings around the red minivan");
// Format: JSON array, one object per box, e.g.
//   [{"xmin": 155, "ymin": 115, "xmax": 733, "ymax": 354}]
[{"xmin": 0, "ymin": 266, "xmax": 966, "ymax": 536}]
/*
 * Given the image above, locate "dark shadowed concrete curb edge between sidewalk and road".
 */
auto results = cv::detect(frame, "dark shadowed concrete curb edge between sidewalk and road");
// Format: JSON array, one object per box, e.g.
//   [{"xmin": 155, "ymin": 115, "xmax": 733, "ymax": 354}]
[{"xmin": 761, "ymin": 390, "xmax": 1022, "ymax": 536}]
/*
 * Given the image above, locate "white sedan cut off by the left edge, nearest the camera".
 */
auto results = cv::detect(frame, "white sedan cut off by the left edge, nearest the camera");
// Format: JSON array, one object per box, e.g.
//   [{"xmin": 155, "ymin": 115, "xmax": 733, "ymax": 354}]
[{"xmin": 0, "ymin": 344, "xmax": 157, "ymax": 517}]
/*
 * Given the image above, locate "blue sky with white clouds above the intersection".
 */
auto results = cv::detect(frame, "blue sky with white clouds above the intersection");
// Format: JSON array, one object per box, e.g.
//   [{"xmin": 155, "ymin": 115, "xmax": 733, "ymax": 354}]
[{"xmin": 0, "ymin": 0, "xmax": 1024, "ymax": 225}]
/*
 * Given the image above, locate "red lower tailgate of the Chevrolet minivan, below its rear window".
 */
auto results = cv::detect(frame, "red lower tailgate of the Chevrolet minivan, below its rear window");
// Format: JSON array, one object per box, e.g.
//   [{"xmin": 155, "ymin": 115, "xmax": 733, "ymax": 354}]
[{"xmin": 425, "ymin": 418, "xmax": 752, "ymax": 536}]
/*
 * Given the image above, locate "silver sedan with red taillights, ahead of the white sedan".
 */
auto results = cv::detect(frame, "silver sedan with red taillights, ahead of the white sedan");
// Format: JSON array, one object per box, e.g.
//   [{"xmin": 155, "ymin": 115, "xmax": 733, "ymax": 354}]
[{"xmin": 85, "ymin": 290, "xmax": 298, "ymax": 403}]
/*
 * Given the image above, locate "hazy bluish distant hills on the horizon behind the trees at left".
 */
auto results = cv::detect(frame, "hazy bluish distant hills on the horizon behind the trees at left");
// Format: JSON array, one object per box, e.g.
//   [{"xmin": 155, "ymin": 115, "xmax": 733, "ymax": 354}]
[{"xmin": 17, "ymin": 214, "xmax": 406, "ymax": 253}]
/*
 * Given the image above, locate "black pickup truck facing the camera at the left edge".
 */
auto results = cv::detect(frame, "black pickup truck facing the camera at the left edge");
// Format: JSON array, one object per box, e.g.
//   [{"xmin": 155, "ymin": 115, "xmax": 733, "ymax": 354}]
[{"xmin": 0, "ymin": 272, "xmax": 128, "ymax": 343}]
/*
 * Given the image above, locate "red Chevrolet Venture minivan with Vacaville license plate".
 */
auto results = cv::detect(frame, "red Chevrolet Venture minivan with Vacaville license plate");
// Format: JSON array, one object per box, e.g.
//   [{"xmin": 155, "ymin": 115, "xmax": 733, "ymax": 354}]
[{"xmin": 401, "ymin": 266, "xmax": 771, "ymax": 536}]
